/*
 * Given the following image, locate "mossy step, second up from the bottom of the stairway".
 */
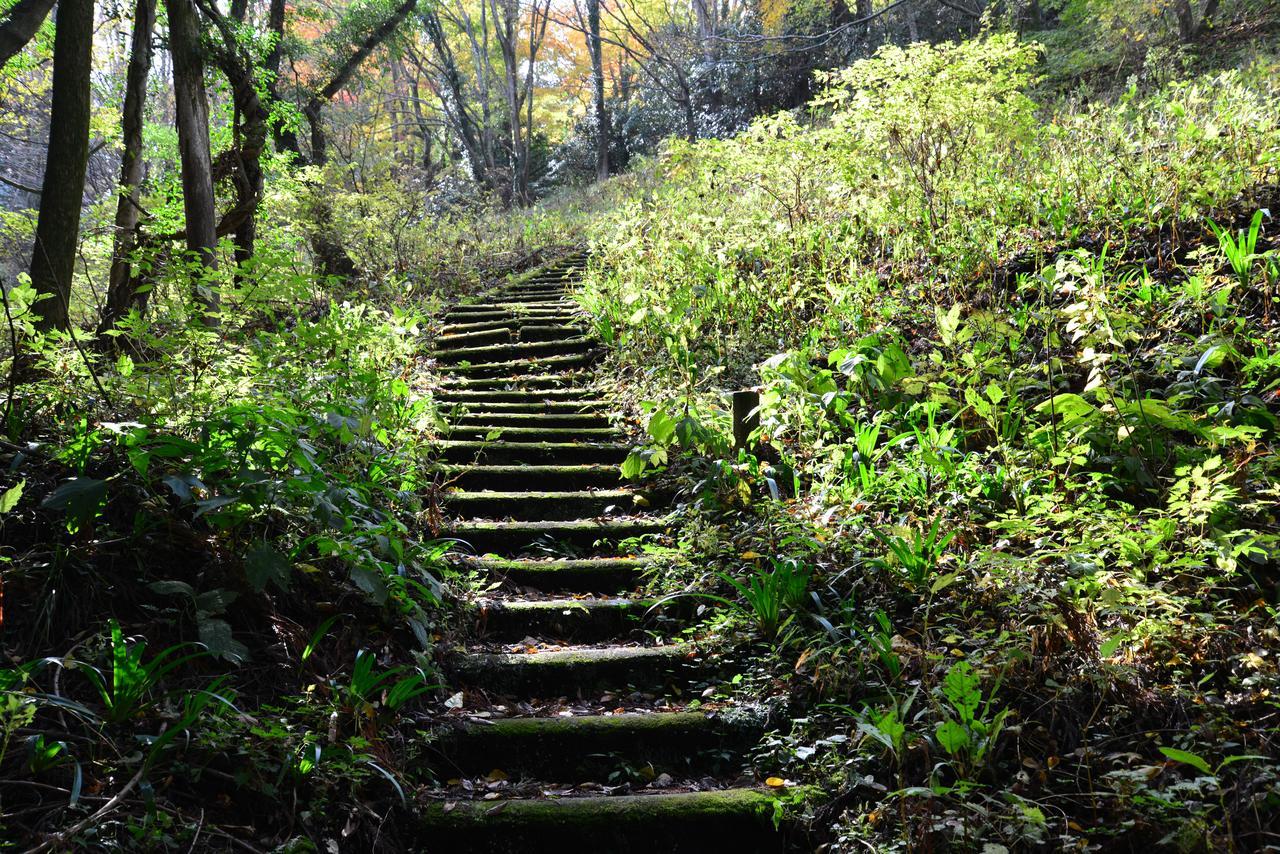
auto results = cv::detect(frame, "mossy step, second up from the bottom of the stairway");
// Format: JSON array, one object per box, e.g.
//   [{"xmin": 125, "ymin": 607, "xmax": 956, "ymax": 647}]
[{"xmin": 431, "ymin": 712, "xmax": 762, "ymax": 781}]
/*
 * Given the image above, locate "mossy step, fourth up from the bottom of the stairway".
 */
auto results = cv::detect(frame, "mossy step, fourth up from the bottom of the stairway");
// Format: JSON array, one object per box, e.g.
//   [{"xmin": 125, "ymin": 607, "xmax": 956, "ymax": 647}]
[{"xmin": 474, "ymin": 597, "xmax": 670, "ymax": 643}]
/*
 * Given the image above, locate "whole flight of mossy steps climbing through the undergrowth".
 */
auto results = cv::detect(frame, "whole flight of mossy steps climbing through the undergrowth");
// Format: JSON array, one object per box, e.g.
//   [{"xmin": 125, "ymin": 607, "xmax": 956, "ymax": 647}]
[{"xmin": 424, "ymin": 257, "xmax": 783, "ymax": 853}]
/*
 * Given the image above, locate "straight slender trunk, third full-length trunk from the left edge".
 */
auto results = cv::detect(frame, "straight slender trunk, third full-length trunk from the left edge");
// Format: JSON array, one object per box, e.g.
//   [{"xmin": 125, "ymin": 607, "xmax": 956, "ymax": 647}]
[{"xmin": 165, "ymin": 0, "xmax": 218, "ymax": 311}]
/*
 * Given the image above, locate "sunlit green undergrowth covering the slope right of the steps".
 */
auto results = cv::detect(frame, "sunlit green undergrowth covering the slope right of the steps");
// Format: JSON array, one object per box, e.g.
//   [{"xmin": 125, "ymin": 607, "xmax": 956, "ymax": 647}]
[{"xmin": 581, "ymin": 36, "xmax": 1280, "ymax": 850}]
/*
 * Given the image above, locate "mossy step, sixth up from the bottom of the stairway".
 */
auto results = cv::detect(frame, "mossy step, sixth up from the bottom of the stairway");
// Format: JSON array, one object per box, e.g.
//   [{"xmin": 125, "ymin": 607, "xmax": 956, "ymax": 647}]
[{"xmin": 448, "ymin": 517, "xmax": 667, "ymax": 556}]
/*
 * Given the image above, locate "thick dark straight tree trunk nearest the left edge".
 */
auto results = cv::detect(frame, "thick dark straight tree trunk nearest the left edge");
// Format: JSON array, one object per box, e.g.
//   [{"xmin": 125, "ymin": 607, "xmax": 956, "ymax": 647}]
[{"xmin": 31, "ymin": 0, "xmax": 93, "ymax": 329}]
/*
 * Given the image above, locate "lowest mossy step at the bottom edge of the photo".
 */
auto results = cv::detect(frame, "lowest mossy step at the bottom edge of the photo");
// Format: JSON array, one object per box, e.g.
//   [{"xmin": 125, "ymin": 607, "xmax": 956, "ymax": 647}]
[{"xmin": 416, "ymin": 789, "xmax": 783, "ymax": 854}]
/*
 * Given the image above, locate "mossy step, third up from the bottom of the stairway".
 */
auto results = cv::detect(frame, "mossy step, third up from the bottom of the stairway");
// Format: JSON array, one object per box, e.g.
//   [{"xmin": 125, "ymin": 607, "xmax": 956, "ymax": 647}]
[{"xmin": 448, "ymin": 644, "xmax": 696, "ymax": 698}]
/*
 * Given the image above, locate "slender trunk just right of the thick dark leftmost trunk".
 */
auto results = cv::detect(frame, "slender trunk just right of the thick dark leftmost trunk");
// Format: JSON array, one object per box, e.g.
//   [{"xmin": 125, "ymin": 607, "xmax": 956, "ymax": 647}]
[{"xmin": 99, "ymin": 0, "xmax": 156, "ymax": 332}]
